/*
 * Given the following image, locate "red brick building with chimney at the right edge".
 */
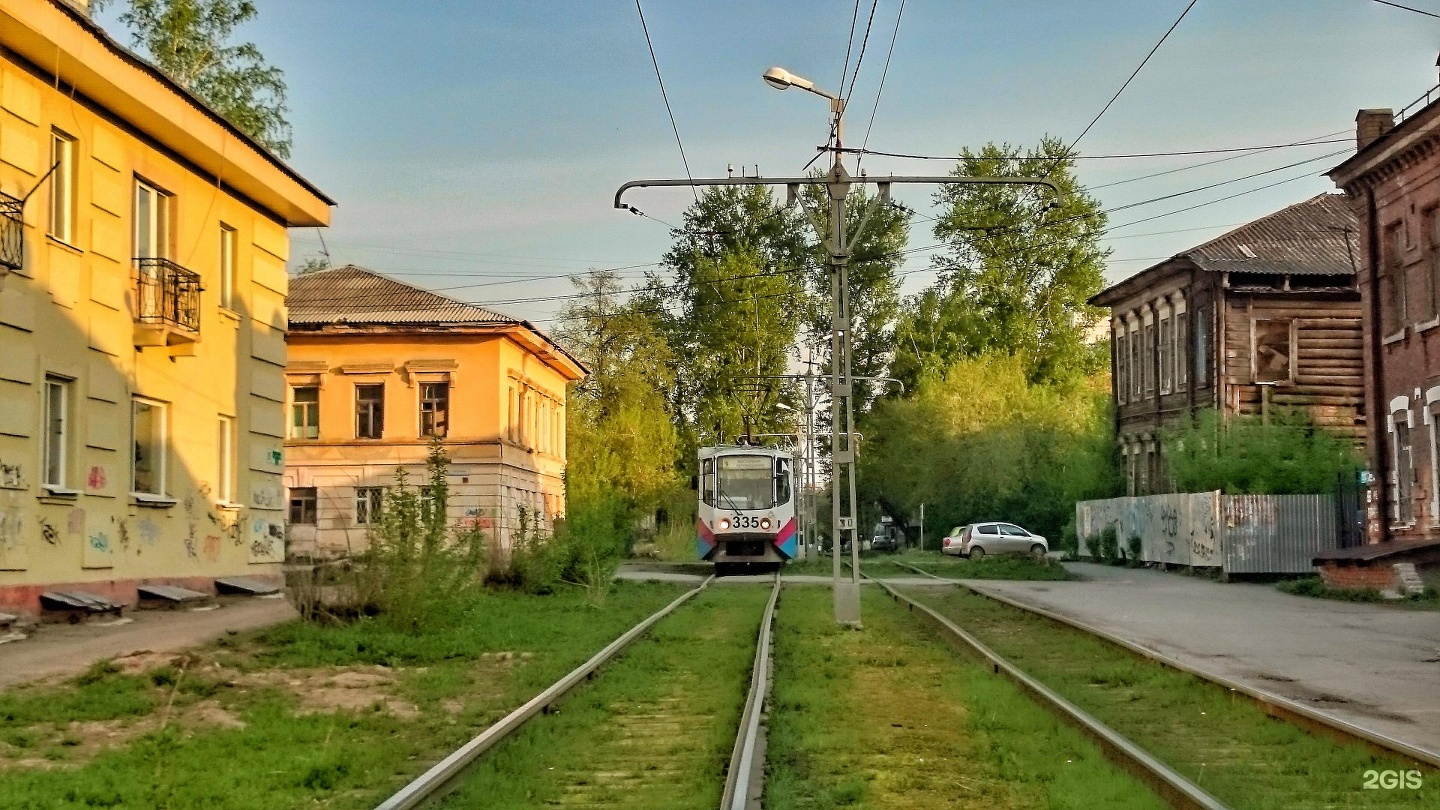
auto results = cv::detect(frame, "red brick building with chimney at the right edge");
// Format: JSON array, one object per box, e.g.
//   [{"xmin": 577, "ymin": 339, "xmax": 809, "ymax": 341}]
[{"xmin": 1326, "ymin": 88, "xmax": 1440, "ymax": 578}]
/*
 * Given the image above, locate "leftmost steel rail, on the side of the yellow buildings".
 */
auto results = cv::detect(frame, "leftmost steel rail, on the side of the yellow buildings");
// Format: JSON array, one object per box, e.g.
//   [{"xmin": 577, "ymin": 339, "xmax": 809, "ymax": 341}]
[{"xmin": 376, "ymin": 577, "xmax": 714, "ymax": 810}]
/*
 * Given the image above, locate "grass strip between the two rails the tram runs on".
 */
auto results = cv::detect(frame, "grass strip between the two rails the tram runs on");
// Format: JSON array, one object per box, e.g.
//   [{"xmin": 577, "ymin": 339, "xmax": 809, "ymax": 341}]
[{"xmin": 442, "ymin": 585, "xmax": 770, "ymax": 810}]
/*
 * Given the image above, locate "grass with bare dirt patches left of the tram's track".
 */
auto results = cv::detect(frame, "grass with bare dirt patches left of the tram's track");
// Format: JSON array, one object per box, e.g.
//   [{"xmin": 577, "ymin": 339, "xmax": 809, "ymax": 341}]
[{"xmin": 0, "ymin": 582, "xmax": 684, "ymax": 810}]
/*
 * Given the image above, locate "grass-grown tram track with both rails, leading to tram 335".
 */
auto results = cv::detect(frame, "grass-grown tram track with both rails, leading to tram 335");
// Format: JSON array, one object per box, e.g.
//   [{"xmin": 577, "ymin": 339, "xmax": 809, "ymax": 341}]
[{"xmin": 377, "ymin": 577, "xmax": 780, "ymax": 810}]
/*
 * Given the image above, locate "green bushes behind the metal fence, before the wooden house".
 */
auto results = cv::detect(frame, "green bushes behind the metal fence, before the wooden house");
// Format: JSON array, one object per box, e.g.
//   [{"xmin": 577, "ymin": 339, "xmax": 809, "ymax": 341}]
[{"xmin": 1164, "ymin": 409, "xmax": 1362, "ymax": 494}]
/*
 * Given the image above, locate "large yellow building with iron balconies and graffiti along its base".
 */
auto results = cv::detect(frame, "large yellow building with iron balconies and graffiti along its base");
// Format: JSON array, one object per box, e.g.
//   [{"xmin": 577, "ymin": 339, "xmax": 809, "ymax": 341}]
[{"xmin": 0, "ymin": 0, "xmax": 333, "ymax": 614}]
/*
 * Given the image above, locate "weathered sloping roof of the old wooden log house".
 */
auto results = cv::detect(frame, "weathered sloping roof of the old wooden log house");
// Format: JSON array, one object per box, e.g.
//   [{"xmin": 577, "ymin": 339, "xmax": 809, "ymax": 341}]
[{"xmin": 1090, "ymin": 193, "xmax": 1358, "ymax": 306}]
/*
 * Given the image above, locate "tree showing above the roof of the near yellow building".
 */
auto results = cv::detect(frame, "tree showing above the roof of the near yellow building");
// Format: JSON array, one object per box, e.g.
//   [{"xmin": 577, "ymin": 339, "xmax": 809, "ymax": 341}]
[{"xmin": 92, "ymin": 0, "xmax": 291, "ymax": 157}]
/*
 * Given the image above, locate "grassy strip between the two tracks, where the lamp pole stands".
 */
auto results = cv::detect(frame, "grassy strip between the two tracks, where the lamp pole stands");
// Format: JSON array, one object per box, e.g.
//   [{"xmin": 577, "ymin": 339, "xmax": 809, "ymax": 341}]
[{"xmin": 765, "ymin": 587, "xmax": 1164, "ymax": 810}]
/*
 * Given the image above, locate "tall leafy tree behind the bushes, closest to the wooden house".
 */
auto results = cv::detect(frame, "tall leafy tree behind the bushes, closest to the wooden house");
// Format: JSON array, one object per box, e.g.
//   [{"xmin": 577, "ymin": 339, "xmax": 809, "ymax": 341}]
[{"xmin": 894, "ymin": 137, "xmax": 1109, "ymax": 385}]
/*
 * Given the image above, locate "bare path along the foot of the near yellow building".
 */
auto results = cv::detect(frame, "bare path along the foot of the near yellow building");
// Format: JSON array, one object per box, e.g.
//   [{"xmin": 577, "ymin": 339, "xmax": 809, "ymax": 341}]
[{"xmin": 0, "ymin": 598, "xmax": 295, "ymax": 687}]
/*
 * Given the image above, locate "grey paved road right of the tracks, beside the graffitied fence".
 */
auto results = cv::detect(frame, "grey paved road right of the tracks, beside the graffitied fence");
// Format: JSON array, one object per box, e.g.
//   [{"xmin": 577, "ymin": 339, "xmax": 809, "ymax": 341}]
[{"xmin": 966, "ymin": 564, "xmax": 1440, "ymax": 751}]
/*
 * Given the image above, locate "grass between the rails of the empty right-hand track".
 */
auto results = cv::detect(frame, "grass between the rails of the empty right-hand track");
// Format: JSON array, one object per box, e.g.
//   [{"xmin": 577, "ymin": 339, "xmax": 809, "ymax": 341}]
[{"xmin": 909, "ymin": 588, "xmax": 1440, "ymax": 810}]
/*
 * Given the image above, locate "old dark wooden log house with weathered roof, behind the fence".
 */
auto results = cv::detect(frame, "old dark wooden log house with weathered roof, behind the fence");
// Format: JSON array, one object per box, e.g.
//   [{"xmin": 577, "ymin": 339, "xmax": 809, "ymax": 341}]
[{"xmin": 1090, "ymin": 195, "xmax": 1365, "ymax": 494}]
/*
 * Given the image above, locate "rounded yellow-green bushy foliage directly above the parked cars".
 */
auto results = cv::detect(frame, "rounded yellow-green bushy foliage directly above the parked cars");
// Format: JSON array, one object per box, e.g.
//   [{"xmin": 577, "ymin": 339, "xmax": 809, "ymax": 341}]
[{"xmin": 860, "ymin": 356, "xmax": 1119, "ymax": 538}]
